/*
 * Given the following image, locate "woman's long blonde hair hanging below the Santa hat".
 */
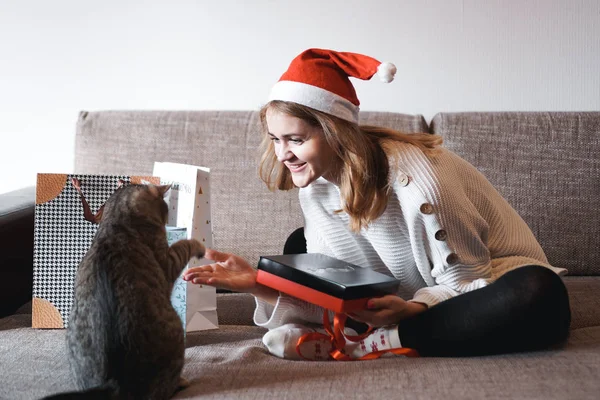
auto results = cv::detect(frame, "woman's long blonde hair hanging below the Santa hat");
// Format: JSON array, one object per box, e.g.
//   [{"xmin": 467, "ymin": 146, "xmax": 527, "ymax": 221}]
[{"xmin": 259, "ymin": 100, "xmax": 442, "ymax": 232}]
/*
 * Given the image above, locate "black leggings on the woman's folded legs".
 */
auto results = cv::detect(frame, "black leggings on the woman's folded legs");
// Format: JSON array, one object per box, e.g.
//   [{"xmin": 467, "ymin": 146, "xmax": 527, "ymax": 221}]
[{"xmin": 284, "ymin": 228, "xmax": 571, "ymax": 357}]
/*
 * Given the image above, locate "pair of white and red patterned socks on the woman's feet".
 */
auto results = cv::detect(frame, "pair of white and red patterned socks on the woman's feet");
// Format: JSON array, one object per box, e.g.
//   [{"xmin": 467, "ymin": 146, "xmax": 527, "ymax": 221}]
[{"xmin": 263, "ymin": 324, "xmax": 401, "ymax": 361}]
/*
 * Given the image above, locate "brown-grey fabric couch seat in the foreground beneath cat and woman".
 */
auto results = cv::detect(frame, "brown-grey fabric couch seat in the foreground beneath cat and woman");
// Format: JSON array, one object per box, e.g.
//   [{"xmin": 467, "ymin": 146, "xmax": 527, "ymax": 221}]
[{"xmin": 0, "ymin": 314, "xmax": 600, "ymax": 400}]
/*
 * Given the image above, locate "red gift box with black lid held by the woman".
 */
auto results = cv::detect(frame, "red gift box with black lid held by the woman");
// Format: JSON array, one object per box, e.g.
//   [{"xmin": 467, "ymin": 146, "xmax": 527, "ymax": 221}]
[{"xmin": 257, "ymin": 253, "xmax": 399, "ymax": 313}]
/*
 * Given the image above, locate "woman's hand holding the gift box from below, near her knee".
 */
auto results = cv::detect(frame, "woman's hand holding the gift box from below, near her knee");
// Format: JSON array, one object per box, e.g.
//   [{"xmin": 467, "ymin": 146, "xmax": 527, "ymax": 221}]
[{"xmin": 348, "ymin": 295, "xmax": 427, "ymax": 327}]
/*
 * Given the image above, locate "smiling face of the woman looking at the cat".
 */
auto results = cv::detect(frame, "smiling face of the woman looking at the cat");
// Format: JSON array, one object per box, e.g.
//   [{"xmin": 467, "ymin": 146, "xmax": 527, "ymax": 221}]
[{"xmin": 266, "ymin": 108, "xmax": 338, "ymax": 188}]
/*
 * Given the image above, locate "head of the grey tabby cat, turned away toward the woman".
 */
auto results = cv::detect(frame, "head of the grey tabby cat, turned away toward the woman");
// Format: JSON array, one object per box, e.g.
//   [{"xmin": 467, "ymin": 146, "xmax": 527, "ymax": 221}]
[{"xmin": 102, "ymin": 184, "xmax": 171, "ymax": 225}]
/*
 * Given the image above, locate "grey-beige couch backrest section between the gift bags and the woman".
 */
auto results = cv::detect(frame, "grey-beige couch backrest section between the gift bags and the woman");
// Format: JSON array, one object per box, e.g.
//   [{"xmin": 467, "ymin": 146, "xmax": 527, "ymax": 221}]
[{"xmin": 75, "ymin": 111, "xmax": 428, "ymax": 265}]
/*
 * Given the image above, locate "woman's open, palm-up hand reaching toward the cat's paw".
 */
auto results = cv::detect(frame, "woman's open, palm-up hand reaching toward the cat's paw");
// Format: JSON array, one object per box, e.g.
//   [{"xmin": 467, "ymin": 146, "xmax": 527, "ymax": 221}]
[{"xmin": 183, "ymin": 249, "xmax": 256, "ymax": 293}]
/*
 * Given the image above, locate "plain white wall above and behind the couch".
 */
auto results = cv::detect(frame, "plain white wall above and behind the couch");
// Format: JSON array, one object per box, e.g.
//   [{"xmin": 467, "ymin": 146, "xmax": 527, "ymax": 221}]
[{"xmin": 0, "ymin": 0, "xmax": 600, "ymax": 192}]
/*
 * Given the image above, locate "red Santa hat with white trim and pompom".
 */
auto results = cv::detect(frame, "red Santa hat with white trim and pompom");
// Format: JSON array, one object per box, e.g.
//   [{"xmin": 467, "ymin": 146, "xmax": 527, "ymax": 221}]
[{"xmin": 269, "ymin": 49, "xmax": 396, "ymax": 123}]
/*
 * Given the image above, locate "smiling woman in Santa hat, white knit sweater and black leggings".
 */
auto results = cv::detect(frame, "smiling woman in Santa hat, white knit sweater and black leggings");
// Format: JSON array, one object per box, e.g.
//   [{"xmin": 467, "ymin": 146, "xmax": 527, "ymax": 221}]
[{"xmin": 185, "ymin": 49, "xmax": 570, "ymax": 359}]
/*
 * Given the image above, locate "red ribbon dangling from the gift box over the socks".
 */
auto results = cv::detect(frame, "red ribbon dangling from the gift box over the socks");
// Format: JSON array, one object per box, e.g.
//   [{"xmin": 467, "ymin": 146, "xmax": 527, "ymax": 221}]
[{"xmin": 296, "ymin": 310, "xmax": 419, "ymax": 361}]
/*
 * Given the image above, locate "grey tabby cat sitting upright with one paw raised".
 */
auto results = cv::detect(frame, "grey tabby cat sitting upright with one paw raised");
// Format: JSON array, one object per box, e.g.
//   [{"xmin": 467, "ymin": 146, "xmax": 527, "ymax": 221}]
[{"xmin": 42, "ymin": 185, "xmax": 205, "ymax": 400}]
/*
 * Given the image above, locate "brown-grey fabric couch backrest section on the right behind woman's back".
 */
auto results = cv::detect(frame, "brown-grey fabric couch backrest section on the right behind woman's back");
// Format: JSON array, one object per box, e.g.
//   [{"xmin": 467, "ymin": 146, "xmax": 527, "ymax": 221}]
[{"xmin": 431, "ymin": 112, "xmax": 600, "ymax": 275}]
